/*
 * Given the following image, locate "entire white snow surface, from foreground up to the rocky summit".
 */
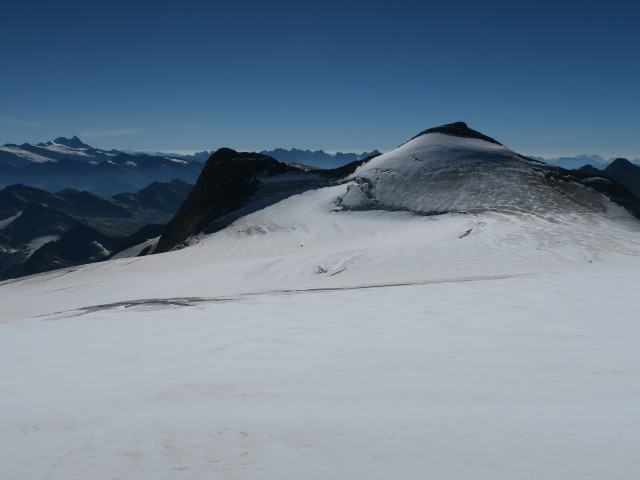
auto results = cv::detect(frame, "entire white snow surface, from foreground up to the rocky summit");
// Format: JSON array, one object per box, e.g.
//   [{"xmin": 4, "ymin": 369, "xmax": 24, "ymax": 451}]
[{"xmin": 0, "ymin": 134, "xmax": 640, "ymax": 480}]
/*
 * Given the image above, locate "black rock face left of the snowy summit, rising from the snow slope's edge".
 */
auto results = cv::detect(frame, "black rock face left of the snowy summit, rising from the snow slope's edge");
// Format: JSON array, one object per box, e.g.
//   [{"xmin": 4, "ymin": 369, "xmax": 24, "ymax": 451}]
[{"xmin": 155, "ymin": 148, "xmax": 299, "ymax": 253}]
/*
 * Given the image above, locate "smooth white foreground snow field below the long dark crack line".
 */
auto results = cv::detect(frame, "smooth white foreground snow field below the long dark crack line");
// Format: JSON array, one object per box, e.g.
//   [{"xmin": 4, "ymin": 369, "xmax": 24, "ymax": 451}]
[{"xmin": 0, "ymin": 268, "xmax": 640, "ymax": 479}]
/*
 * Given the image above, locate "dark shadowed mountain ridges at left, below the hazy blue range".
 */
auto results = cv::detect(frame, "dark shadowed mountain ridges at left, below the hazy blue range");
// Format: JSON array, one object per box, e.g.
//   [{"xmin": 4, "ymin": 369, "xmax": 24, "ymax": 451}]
[{"xmin": 0, "ymin": 179, "xmax": 192, "ymax": 279}]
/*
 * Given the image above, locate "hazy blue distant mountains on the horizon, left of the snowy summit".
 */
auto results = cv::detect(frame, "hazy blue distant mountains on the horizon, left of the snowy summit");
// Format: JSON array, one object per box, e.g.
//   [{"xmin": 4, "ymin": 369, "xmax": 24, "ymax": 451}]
[{"xmin": 0, "ymin": 136, "xmax": 379, "ymax": 195}]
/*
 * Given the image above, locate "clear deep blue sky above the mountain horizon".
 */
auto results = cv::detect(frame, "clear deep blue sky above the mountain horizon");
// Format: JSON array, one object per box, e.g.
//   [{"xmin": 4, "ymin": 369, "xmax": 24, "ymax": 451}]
[{"xmin": 0, "ymin": 0, "xmax": 640, "ymax": 158}]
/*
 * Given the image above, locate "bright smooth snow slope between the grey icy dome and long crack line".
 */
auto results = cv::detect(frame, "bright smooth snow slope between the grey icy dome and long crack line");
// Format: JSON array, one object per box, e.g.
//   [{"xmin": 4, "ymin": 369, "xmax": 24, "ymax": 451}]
[{"xmin": 5, "ymin": 173, "xmax": 640, "ymax": 318}]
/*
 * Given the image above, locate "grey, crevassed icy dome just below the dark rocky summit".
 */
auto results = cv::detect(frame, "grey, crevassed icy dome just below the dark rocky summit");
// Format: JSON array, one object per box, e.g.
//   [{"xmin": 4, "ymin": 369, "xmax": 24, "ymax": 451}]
[{"xmin": 343, "ymin": 129, "xmax": 628, "ymax": 217}]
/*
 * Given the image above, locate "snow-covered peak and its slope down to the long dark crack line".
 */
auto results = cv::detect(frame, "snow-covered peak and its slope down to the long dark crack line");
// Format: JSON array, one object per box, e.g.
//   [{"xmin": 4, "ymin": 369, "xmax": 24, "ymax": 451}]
[{"xmin": 2, "ymin": 122, "xmax": 640, "ymax": 316}]
